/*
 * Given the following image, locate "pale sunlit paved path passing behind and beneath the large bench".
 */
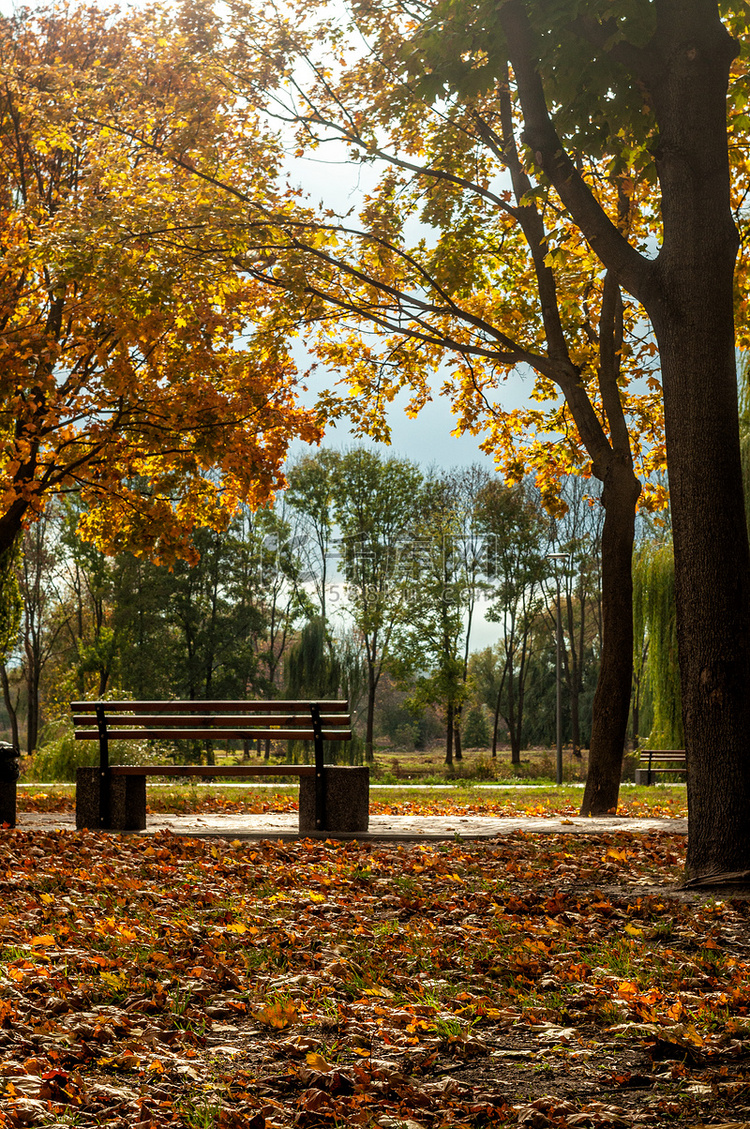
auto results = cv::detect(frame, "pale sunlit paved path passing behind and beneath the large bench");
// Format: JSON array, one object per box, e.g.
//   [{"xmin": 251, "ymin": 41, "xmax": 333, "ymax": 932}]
[{"xmin": 11, "ymin": 812, "xmax": 688, "ymax": 842}]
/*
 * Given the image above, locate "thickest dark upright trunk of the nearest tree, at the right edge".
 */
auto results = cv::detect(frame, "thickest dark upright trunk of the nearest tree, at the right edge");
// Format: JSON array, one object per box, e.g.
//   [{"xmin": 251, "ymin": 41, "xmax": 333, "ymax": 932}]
[{"xmin": 647, "ymin": 0, "xmax": 750, "ymax": 877}]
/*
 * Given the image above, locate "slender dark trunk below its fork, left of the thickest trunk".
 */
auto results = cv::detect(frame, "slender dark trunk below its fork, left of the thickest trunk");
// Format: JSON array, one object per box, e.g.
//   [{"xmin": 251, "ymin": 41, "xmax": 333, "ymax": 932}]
[{"xmin": 581, "ymin": 462, "xmax": 640, "ymax": 815}]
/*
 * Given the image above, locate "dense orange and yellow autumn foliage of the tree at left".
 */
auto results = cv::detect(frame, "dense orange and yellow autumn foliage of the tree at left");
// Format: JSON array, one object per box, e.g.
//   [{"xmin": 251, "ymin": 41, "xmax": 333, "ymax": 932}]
[{"xmin": 0, "ymin": 8, "xmax": 320, "ymax": 558}]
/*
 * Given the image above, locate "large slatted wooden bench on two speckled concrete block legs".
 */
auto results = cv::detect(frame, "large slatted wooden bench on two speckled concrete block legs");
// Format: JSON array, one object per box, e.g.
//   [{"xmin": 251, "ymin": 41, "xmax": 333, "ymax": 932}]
[{"xmin": 71, "ymin": 701, "xmax": 369, "ymax": 834}]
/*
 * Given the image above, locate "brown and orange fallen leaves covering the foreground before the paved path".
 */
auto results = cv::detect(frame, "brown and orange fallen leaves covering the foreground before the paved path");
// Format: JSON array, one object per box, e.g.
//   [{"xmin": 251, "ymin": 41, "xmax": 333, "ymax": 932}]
[{"xmin": 0, "ymin": 830, "xmax": 750, "ymax": 1129}]
